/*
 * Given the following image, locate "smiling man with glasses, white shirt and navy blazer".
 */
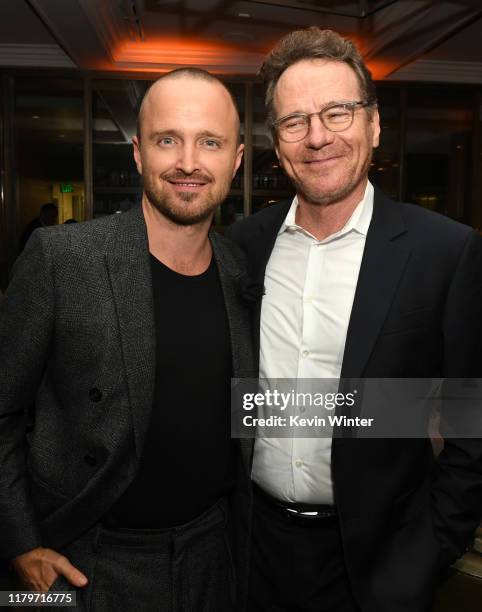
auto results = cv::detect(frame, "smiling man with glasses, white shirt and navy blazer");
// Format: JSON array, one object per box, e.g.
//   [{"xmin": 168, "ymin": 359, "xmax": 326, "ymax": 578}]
[{"xmin": 230, "ymin": 27, "xmax": 482, "ymax": 612}]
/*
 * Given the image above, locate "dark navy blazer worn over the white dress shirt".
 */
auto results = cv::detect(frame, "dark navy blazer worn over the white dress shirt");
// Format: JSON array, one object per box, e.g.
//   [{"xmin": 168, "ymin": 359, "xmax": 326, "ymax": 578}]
[{"xmin": 228, "ymin": 189, "xmax": 482, "ymax": 612}]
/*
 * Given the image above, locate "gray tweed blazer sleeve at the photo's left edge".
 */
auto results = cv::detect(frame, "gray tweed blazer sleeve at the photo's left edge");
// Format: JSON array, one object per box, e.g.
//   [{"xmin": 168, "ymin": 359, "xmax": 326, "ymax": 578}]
[{"xmin": 0, "ymin": 230, "xmax": 54, "ymax": 559}]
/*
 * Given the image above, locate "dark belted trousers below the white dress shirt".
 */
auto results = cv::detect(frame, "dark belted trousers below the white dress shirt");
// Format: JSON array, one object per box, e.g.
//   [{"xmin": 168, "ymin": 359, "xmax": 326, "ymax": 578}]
[{"xmin": 248, "ymin": 493, "xmax": 360, "ymax": 612}]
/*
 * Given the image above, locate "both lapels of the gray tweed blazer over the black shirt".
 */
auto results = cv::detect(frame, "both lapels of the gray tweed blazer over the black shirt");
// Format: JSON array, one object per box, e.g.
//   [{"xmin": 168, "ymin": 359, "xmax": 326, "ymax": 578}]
[{"xmin": 106, "ymin": 213, "xmax": 256, "ymax": 468}]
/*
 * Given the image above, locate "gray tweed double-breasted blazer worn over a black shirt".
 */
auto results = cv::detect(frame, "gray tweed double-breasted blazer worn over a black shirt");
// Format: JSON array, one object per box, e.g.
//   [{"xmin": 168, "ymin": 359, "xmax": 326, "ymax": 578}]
[{"xmin": 0, "ymin": 207, "xmax": 255, "ymax": 559}]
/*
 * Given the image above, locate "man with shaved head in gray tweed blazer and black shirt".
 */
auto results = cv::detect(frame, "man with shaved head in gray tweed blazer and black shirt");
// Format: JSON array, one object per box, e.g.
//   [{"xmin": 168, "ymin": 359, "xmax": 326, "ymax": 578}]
[{"xmin": 0, "ymin": 69, "xmax": 253, "ymax": 612}]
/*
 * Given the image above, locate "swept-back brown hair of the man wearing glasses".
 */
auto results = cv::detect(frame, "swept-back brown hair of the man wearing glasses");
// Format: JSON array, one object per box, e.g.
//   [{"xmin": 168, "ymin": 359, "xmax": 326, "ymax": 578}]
[{"xmin": 258, "ymin": 26, "xmax": 377, "ymax": 131}]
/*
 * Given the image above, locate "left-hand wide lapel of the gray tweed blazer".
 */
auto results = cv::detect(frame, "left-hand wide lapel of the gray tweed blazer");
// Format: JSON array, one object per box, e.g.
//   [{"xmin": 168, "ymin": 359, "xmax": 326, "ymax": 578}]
[{"xmin": 106, "ymin": 206, "xmax": 156, "ymax": 458}]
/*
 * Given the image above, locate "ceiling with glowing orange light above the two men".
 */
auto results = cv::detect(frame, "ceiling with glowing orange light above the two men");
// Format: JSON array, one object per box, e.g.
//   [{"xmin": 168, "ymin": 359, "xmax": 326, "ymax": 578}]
[{"xmin": 0, "ymin": 0, "xmax": 482, "ymax": 83}]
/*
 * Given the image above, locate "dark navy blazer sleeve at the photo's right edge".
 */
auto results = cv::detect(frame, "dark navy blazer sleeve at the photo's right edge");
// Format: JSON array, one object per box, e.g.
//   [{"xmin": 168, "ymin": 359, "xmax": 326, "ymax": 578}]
[{"xmin": 431, "ymin": 232, "xmax": 482, "ymax": 564}]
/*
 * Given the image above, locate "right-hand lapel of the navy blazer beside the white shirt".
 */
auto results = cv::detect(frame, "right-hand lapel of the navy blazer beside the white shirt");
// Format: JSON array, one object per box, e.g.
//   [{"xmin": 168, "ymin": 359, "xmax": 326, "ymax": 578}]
[{"xmin": 341, "ymin": 189, "xmax": 410, "ymax": 378}]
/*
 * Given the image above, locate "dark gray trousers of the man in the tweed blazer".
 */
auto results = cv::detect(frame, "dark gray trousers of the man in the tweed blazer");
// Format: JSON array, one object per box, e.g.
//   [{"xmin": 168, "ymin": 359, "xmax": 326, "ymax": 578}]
[{"xmin": 38, "ymin": 500, "xmax": 235, "ymax": 612}]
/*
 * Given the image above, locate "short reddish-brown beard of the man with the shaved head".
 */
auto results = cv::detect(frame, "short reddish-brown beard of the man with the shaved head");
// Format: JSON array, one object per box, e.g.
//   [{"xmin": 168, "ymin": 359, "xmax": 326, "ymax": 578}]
[{"xmin": 142, "ymin": 172, "xmax": 231, "ymax": 226}]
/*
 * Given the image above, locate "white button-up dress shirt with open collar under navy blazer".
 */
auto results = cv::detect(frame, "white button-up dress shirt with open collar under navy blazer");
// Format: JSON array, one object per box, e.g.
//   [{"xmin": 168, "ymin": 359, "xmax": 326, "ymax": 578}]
[{"xmin": 252, "ymin": 182, "xmax": 373, "ymax": 504}]
